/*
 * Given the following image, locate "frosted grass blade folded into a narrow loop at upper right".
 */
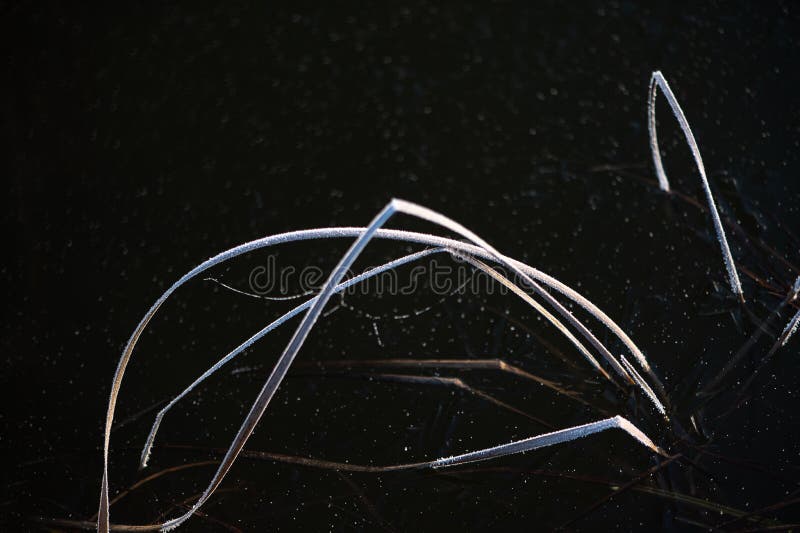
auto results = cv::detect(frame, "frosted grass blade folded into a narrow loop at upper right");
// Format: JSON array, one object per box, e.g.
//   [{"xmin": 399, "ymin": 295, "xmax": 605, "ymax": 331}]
[{"xmin": 647, "ymin": 70, "xmax": 744, "ymax": 302}]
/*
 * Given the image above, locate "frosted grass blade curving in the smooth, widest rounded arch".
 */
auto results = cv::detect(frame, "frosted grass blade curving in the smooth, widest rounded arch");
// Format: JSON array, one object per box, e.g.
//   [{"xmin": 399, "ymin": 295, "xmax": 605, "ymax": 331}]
[{"xmin": 97, "ymin": 217, "xmax": 663, "ymax": 532}]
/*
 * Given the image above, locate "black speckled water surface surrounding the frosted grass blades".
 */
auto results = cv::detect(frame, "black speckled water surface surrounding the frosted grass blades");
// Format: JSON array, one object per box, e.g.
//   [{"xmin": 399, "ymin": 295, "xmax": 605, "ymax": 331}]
[{"xmin": 0, "ymin": 2, "xmax": 800, "ymax": 531}]
